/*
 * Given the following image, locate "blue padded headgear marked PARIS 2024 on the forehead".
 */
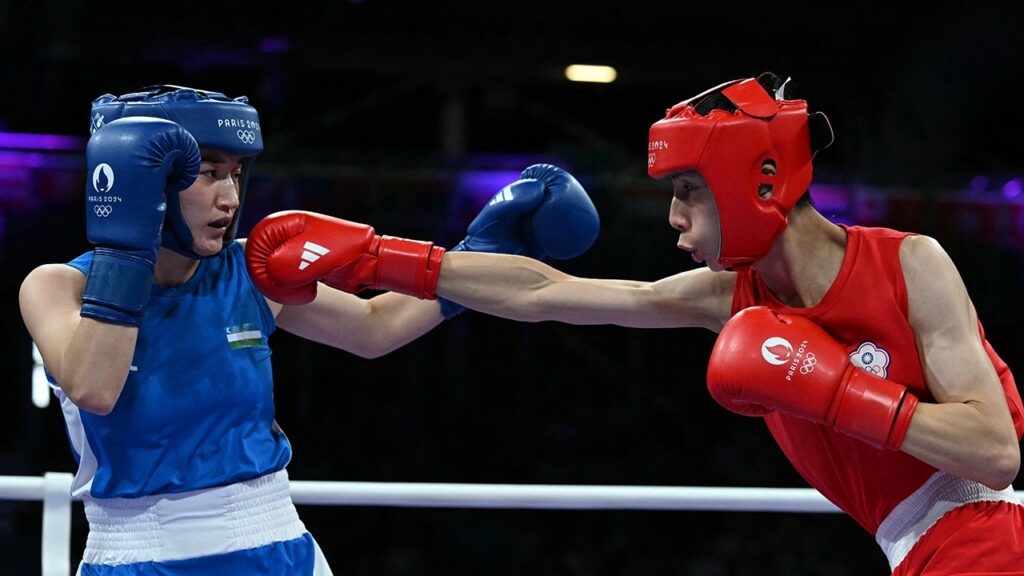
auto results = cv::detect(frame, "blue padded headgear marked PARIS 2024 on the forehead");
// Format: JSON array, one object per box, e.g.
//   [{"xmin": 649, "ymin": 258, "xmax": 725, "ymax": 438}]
[{"xmin": 89, "ymin": 85, "xmax": 263, "ymax": 258}]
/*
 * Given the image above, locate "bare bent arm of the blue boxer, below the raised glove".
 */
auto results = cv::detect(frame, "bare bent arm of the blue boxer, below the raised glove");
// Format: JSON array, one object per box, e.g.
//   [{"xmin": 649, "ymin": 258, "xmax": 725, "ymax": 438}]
[{"xmin": 18, "ymin": 264, "xmax": 138, "ymax": 414}]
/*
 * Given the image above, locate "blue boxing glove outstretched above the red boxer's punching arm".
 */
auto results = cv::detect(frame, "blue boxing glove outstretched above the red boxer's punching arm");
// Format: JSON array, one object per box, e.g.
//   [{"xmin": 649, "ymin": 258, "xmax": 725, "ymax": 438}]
[{"xmin": 438, "ymin": 164, "xmax": 601, "ymax": 318}]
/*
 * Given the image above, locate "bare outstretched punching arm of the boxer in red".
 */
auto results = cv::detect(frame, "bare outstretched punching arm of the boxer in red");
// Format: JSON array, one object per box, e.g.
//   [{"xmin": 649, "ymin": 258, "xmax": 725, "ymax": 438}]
[{"xmin": 437, "ymin": 252, "xmax": 736, "ymax": 331}]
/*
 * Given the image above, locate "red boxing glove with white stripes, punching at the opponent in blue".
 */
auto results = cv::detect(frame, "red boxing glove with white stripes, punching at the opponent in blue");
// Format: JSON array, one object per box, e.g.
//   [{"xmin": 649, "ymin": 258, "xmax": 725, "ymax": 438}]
[{"xmin": 246, "ymin": 210, "xmax": 444, "ymax": 304}]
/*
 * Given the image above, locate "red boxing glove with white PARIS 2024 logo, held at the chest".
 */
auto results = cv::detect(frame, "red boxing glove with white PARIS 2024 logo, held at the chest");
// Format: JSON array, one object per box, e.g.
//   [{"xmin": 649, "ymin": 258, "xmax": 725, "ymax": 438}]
[{"xmin": 708, "ymin": 306, "xmax": 918, "ymax": 450}]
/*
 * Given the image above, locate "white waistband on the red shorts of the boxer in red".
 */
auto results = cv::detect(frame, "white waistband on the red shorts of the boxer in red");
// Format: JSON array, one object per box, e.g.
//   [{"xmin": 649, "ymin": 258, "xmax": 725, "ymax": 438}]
[{"xmin": 874, "ymin": 470, "xmax": 1021, "ymax": 571}]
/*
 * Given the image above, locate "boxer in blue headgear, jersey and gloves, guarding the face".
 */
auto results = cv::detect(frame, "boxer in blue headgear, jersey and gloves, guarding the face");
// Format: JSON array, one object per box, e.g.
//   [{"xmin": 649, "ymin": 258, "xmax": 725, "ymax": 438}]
[{"xmin": 19, "ymin": 86, "xmax": 597, "ymax": 576}]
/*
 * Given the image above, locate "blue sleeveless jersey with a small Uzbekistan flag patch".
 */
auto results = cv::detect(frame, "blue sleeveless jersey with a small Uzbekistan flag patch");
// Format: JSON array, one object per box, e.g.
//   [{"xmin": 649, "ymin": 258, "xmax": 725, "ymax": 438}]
[{"xmin": 53, "ymin": 242, "xmax": 292, "ymax": 498}]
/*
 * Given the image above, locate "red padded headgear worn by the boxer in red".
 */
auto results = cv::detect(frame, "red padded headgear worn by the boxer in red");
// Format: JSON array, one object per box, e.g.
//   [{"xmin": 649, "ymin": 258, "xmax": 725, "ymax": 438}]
[{"xmin": 647, "ymin": 78, "xmax": 831, "ymax": 268}]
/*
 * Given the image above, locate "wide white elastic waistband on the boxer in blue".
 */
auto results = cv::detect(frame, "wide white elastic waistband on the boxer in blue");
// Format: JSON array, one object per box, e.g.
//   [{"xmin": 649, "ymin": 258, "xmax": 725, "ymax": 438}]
[{"xmin": 82, "ymin": 470, "xmax": 306, "ymax": 565}]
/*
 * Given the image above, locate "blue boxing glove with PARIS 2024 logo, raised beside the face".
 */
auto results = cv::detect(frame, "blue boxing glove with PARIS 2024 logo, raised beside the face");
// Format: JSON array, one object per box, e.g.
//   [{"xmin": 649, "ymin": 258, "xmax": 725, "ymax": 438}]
[{"xmin": 81, "ymin": 117, "xmax": 201, "ymax": 326}]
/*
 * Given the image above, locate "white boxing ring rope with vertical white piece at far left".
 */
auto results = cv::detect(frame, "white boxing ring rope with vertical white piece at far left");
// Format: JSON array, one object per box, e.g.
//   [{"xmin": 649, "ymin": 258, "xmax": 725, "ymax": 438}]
[{"xmin": 6, "ymin": 472, "xmax": 1024, "ymax": 576}]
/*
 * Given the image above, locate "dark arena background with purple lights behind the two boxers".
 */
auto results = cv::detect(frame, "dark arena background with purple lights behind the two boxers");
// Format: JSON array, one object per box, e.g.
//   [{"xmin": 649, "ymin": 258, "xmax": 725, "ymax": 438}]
[{"xmin": 0, "ymin": 0, "xmax": 1024, "ymax": 576}]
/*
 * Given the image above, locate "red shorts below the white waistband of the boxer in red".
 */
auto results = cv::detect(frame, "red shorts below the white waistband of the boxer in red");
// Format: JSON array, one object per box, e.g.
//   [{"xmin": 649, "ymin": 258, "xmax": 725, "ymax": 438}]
[{"xmin": 893, "ymin": 502, "xmax": 1024, "ymax": 576}]
